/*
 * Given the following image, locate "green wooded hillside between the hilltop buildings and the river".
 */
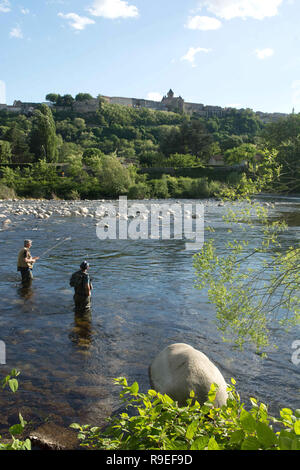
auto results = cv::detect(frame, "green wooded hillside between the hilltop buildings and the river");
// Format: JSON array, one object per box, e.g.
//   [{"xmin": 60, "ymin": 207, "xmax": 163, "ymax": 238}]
[{"xmin": 0, "ymin": 94, "xmax": 300, "ymax": 199}]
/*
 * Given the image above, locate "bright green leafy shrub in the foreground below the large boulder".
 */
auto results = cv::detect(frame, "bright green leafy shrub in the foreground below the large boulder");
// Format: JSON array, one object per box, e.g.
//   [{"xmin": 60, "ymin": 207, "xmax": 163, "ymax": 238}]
[{"xmin": 71, "ymin": 377, "xmax": 300, "ymax": 451}]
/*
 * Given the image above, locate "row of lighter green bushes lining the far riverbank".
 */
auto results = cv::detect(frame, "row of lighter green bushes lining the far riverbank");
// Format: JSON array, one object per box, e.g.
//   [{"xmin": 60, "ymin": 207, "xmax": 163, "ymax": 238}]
[{"xmin": 0, "ymin": 162, "xmax": 224, "ymax": 199}]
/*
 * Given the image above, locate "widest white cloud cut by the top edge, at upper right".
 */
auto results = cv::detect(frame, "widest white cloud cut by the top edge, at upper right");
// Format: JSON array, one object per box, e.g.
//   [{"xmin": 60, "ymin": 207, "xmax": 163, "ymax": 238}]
[{"xmin": 201, "ymin": 0, "xmax": 283, "ymax": 20}]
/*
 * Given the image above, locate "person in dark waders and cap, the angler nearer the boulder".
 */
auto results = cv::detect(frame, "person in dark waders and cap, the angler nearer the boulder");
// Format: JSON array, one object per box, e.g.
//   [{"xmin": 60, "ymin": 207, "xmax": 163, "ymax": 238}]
[{"xmin": 70, "ymin": 261, "xmax": 93, "ymax": 313}]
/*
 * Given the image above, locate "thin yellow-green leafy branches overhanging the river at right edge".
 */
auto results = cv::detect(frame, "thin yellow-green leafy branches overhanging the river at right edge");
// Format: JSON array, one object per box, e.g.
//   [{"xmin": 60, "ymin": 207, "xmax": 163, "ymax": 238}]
[{"xmin": 194, "ymin": 151, "xmax": 300, "ymax": 352}]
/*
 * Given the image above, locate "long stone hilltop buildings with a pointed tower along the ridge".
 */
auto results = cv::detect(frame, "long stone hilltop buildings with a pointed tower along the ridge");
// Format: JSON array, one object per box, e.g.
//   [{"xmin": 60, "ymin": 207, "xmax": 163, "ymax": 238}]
[{"xmin": 0, "ymin": 89, "xmax": 288, "ymax": 123}]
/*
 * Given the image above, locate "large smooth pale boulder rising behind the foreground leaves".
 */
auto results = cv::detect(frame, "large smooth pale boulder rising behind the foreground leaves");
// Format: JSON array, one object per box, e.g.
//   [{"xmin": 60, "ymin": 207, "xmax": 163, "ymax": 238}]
[{"xmin": 149, "ymin": 343, "xmax": 228, "ymax": 407}]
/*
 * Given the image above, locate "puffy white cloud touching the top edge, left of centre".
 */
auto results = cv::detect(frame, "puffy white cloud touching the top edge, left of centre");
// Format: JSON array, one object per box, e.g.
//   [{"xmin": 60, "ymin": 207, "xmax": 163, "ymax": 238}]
[{"xmin": 88, "ymin": 0, "xmax": 139, "ymax": 19}]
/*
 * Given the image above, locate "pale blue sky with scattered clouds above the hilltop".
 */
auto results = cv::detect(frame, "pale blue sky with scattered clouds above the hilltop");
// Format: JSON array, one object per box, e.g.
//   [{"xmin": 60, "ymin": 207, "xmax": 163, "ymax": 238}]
[{"xmin": 0, "ymin": 0, "xmax": 300, "ymax": 113}]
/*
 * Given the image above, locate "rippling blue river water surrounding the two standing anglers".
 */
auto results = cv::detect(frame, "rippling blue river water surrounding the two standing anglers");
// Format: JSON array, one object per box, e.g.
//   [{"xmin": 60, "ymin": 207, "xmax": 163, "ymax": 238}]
[{"xmin": 0, "ymin": 198, "xmax": 300, "ymax": 434}]
